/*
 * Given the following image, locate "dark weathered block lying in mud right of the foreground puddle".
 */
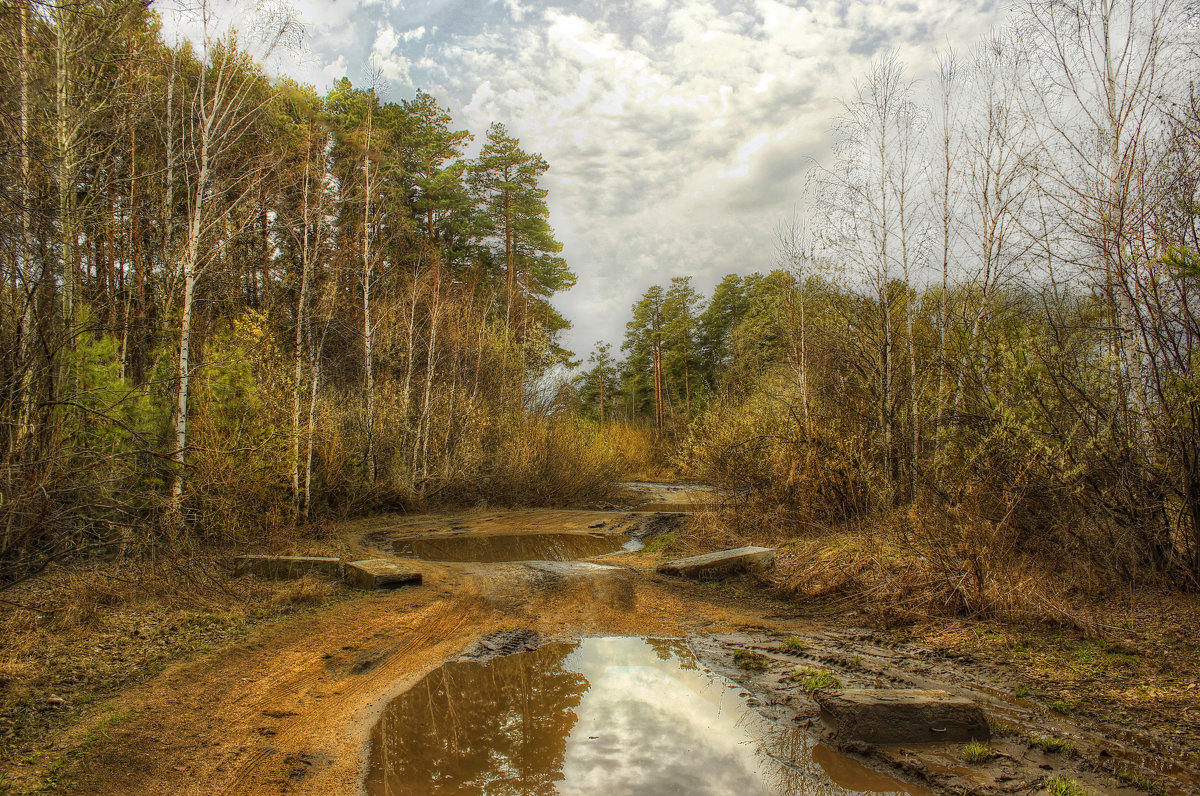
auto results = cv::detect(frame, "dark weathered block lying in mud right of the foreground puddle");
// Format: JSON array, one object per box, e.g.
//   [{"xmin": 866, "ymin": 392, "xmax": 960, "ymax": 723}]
[{"xmin": 814, "ymin": 688, "xmax": 991, "ymax": 743}]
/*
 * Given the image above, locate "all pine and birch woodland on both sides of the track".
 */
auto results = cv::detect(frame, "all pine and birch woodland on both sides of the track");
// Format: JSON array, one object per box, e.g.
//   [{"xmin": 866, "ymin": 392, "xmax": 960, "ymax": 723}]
[{"xmin": 0, "ymin": 0, "xmax": 1200, "ymax": 612}]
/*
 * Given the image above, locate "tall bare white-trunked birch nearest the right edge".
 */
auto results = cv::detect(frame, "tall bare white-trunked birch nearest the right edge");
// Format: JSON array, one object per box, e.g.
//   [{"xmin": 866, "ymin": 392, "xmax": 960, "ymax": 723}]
[{"xmin": 1019, "ymin": 0, "xmax": 1188, "ymax": 436}]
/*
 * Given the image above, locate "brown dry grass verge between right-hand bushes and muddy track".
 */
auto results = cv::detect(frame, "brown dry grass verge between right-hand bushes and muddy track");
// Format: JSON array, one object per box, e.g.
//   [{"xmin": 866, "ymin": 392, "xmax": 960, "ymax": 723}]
[{"xmin": 670, "ymin": 499, "xmax": 1200, "ymax": 747}]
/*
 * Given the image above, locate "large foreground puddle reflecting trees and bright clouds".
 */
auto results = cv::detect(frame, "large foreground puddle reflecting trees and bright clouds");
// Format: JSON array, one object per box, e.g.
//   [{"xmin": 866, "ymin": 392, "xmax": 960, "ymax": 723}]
[{"xmin": 366, "ymin": 638, "xmax": 928, "ymax": 796}]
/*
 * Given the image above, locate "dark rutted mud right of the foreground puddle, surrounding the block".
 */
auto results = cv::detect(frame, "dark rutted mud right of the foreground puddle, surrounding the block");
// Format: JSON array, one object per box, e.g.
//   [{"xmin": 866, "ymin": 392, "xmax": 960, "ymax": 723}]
[{"xmin": 694, "ymin": 629, "xmax": 1200, "ymax": 794}]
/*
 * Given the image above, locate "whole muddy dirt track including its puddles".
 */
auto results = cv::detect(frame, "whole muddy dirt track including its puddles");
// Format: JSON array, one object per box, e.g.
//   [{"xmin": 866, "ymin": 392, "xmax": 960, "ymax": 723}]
[{"xmin": 35, "ymin": 484, "xmax": 1200, "ymax": 796}]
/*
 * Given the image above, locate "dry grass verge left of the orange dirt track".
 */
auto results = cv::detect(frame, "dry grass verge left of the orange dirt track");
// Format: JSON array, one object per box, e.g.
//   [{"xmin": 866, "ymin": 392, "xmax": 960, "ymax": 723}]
[{"xmin": 0, "ymin": 545, "xmax": 354, "ymax": 764}]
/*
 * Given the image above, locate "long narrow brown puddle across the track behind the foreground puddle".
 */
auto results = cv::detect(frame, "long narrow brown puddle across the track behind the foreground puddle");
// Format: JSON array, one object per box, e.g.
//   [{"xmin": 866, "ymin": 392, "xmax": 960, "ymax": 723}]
[{"xmin": 392, "ymin": 533, "xmax": 641, "ymax": 563}]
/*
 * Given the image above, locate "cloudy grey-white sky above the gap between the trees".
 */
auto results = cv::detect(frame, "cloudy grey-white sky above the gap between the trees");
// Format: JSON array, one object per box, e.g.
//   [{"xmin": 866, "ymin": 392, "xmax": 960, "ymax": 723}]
[{"xmin": 160, "ymin": 0, "xmax": 1004, "ymax": 357}]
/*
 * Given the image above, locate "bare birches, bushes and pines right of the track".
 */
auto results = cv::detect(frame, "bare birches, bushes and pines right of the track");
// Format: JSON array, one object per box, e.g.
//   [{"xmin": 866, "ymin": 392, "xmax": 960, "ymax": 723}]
[{"xmin": 576, "ymin": 0, "xmax": 1200, "ymax": 593}]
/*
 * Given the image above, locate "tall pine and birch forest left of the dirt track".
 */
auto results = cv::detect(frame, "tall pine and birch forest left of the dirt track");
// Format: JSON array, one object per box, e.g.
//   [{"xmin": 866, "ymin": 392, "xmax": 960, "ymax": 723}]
[{"xmin": 0, "ymin": 0, "xmax": 638, "ymax": 583}]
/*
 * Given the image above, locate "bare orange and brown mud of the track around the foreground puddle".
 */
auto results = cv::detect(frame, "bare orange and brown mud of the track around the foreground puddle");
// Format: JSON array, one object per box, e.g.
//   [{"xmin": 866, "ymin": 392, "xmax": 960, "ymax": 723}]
[{"xmin": 4, "ymin": 490, "xmax": 1200, "ymax": 796}]
